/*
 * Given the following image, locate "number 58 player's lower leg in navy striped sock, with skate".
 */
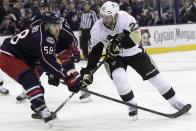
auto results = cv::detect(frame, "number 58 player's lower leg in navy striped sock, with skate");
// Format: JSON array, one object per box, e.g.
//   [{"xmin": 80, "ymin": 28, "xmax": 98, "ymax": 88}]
[{"xmin": 18, "ymin": 70, "xmax": 53, "ymax": 122}]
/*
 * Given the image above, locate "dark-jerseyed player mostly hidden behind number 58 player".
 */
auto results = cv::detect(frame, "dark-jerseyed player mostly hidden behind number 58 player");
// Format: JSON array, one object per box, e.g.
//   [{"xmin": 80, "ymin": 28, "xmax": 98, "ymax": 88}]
[{"xmin": 16, "ymin": 0, "xmax": 92, "ymax": 102}]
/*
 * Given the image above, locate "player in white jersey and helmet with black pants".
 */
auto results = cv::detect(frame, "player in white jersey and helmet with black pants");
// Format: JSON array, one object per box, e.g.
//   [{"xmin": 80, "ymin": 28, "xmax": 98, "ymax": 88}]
[{"xmin": 81, "ymin": 1, "xmax": 191, "ymax": 119}]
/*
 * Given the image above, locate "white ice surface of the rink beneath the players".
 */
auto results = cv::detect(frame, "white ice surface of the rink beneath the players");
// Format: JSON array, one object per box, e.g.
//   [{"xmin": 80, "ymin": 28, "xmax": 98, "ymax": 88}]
[{"xmin": 0, "ymin": 51, "xmax": 196, "ymax": 131}]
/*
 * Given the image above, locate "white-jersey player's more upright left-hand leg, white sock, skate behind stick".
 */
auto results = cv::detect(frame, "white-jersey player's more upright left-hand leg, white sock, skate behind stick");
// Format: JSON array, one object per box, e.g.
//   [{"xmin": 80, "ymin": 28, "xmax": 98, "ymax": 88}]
[{"xmin": 105, "ymin": 57, "xmax": 137, "ymax": 120}]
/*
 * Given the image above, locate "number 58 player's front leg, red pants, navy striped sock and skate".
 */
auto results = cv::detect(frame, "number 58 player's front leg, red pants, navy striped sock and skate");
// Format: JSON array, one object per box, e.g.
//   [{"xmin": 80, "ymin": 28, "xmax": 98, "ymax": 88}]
[{"xmin": 0, "ymin": 54, "xmax": 53, "ymax": 122}]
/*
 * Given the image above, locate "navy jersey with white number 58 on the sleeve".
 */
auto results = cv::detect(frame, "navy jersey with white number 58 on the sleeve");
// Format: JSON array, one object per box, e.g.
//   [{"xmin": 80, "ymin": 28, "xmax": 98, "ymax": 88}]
[{"xmin": 1, "ymin": 25, "xmax": 66, "ymax": 78}]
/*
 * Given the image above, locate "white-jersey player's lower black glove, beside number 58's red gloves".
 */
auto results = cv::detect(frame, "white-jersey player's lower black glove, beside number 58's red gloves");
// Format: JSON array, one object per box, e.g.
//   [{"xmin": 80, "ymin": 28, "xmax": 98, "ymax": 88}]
[{"xmin": 80, "ymin": 68, "xmax": 93, "ymax": 88}]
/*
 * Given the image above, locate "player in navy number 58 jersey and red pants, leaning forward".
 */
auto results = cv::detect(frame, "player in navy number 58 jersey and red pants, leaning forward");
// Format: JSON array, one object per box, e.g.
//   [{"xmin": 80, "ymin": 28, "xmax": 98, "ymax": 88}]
[{"xmin": 0, "ymin": 12, "xmax": 79, "ymax": 122}]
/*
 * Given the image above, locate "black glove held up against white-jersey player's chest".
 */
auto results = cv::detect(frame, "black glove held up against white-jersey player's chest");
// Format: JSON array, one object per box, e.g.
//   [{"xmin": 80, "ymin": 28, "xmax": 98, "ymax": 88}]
[{"xmin": 106, "ymin": 33, "xmax": 124, "ymax": 57}]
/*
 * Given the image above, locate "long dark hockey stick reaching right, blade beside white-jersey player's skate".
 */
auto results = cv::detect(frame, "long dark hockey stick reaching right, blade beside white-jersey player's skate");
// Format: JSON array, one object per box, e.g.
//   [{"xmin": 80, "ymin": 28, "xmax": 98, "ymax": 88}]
[{"xmin": 81, "ymin": 89, "xmax": 191, "ymax": 118}]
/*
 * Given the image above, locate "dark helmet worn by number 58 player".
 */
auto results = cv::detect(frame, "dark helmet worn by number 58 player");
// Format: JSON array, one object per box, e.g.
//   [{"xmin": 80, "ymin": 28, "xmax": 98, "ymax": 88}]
[{"xmin": 42, "ymin": 11, "xmax": 61, "ymax": 24}]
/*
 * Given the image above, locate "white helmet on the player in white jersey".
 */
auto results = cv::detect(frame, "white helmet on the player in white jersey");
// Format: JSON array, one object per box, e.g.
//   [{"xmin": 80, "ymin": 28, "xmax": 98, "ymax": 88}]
[{"xmin": 100, "ymin": 1, "xmax": 120, "ymax": 18}]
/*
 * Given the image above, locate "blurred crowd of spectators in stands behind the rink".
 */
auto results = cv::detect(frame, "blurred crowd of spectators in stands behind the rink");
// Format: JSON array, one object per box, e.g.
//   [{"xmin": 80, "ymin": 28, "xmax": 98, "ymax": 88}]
[{"xmin": 0, "ymin": 0, "xmax": 196, "ymax": 35}]
